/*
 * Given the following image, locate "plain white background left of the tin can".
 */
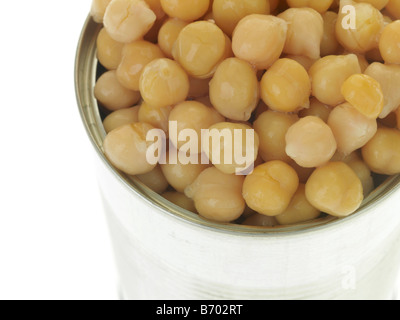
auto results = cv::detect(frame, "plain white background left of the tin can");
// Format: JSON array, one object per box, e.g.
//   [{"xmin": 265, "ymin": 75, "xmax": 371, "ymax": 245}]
[{"xmin": 0, "ymin": 0, "xmax": 118, "ymax": 299}]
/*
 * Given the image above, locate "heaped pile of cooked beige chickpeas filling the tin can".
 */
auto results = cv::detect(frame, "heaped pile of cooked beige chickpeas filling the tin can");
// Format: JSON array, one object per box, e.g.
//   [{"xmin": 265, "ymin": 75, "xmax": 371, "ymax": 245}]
[{"xmin": 91, "ymin": 0, "xmax": 400, "ymax": 227}]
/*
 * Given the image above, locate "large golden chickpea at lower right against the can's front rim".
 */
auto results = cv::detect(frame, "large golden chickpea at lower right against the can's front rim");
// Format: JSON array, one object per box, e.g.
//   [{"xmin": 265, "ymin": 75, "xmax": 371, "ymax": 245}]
[{"xmin": 306, "ymin": 162, "xmax": 364, "ymax": 217}]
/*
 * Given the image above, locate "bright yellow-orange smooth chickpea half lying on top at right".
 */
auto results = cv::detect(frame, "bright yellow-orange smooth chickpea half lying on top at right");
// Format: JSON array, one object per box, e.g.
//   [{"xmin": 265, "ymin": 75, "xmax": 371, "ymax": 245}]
[{"xmin": 341, "ymin": 74, "xmax": 384, "ymax": 119}]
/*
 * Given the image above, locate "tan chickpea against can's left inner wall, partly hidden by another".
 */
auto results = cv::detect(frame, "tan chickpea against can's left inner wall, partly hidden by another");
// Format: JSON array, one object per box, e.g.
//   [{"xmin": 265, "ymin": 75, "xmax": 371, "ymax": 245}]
[{"xmin": 94, "ymin": 71, "xmax": 140, "ymax": 111}]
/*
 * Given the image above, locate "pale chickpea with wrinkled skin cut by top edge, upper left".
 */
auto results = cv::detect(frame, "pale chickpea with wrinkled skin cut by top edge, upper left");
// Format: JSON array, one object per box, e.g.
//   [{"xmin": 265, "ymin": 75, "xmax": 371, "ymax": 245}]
[{"xmin": 104, "ymin": 0, "xmax": 157, "ymax": 43}]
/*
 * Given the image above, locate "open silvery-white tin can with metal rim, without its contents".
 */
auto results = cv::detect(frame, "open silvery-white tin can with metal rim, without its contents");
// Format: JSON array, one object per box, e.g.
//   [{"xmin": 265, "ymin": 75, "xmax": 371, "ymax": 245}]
[{"xmin": 75, "ymin": 18, "xmax": 400, "ymax": 300}]
